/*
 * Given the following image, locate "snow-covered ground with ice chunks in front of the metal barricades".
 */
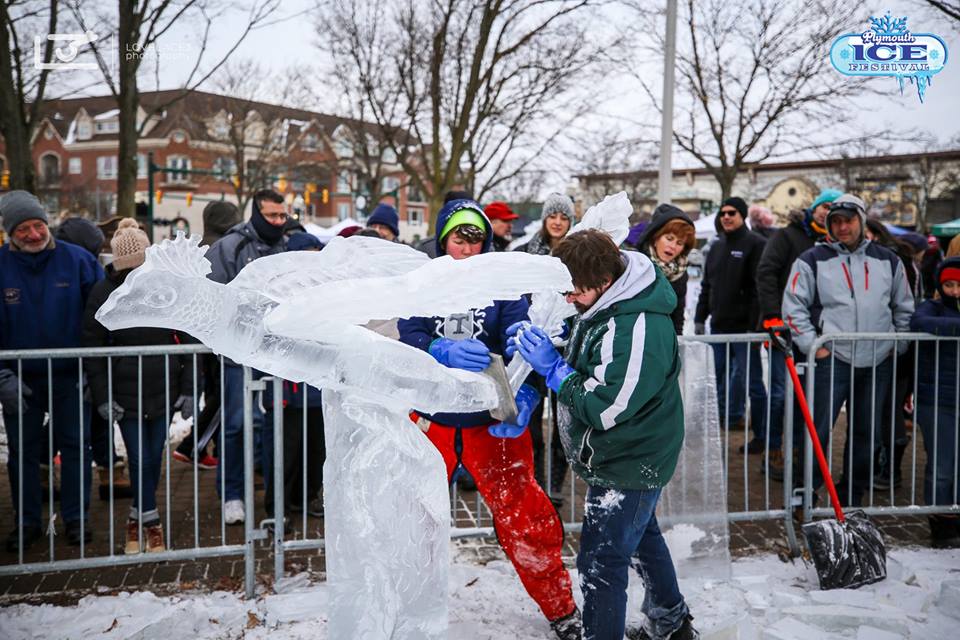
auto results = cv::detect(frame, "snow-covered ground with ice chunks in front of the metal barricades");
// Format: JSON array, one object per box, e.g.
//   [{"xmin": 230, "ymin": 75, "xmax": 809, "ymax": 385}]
[{"xmin": 0, "ymin": 549, "xmax": 960, "ymax": 640}]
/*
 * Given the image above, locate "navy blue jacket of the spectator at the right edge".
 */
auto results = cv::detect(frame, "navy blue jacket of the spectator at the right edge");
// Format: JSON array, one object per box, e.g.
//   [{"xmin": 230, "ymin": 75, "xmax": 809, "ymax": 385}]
[{"xmin": 910, "ymin": 258, "xmax": 960, "ymax": 407}]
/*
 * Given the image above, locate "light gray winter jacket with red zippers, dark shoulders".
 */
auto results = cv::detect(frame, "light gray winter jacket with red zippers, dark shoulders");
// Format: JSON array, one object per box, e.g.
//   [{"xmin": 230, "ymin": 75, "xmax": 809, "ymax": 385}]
[{"xmin": 783, "ymin": 240, "xmax": 913, "ymax": 367}]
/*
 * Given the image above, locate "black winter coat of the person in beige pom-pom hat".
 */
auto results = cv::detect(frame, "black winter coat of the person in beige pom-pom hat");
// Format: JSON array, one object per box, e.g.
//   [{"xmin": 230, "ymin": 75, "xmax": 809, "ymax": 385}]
[{"xmin": 83, "ymin": 266, "xmax": 195, "ymax": 418}]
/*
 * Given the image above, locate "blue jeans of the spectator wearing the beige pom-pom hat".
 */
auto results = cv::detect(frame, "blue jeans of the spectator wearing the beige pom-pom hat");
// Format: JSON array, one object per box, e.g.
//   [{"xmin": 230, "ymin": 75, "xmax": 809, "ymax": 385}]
[{"xmin": 120, "ymin": 416, "xmax": 167, "ymax": 523}]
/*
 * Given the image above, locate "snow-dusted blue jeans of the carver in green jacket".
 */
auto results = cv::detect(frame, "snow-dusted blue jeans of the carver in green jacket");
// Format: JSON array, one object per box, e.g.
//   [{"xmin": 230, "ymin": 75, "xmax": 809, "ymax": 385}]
[{"xmin": 577, "ymin": 487, "xmax": 689, "ymax": 640}]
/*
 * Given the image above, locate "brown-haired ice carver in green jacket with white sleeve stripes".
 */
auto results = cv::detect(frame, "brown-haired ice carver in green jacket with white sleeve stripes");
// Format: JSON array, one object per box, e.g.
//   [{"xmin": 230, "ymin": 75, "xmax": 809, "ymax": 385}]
[{"xmin": 508, "ymin": 230, "xmax": 699, "ymax": 640}]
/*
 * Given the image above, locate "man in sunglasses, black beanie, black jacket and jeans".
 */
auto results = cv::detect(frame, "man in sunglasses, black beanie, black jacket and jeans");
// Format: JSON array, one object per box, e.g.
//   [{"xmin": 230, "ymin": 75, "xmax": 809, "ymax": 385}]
[{"xmin": 694, "ymin": 197, "xmax": 767, "ymax": 454}]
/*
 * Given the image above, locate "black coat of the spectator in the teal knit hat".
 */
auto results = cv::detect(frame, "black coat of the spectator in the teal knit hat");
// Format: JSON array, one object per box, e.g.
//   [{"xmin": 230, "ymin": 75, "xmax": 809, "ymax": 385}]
[{"xmin": 757, "ymin": 214, "xmax": 823, "ymax": 319}]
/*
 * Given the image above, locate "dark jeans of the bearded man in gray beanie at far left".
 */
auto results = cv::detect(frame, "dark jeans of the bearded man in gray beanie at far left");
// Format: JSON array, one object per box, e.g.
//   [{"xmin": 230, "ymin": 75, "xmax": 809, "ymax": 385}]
[{"xmin": 3, "ymin": 373, "xmax": 93, "ymax": 530}]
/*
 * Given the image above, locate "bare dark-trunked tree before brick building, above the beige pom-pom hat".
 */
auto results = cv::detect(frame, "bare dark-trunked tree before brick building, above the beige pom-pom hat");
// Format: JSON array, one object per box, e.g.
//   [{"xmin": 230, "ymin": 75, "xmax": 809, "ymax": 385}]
[{"xmin": 71, "ymin": 0, "xmax": 280, "ymax": 220}]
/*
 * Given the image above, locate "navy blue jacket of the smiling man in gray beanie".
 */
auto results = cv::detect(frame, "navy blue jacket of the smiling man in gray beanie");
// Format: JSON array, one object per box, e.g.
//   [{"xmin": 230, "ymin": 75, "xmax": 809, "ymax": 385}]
[{"xmin": 0, "ymin": 240, "xmax": 103, "ymax": 375}]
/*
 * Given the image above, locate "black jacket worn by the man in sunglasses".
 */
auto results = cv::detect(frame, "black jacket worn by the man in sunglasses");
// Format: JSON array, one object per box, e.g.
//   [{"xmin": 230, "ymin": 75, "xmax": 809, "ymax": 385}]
[{"xmin": 694, "ymin": 225, "xmax": 766, "ymax": 333}]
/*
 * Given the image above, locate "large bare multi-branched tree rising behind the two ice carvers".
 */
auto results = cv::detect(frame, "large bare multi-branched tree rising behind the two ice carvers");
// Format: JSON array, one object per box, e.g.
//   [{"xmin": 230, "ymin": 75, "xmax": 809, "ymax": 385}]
[{"xmin": 319, "ymin": 0, "xmax": 603, "ymax": 230}]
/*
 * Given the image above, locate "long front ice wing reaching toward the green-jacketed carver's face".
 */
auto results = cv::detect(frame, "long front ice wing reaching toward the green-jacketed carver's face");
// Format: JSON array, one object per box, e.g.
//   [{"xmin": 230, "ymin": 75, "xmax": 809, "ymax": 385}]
[{"xmin": 266, "ymin": 252, "xmax": 573, "ymax": 338}]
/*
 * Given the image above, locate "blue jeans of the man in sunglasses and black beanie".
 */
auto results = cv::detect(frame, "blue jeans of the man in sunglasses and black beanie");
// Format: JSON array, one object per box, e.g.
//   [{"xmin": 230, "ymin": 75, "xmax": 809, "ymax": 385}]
[{"xmin": 711, "ymin": 342, "xmax": 783, "ymax": 440}]
